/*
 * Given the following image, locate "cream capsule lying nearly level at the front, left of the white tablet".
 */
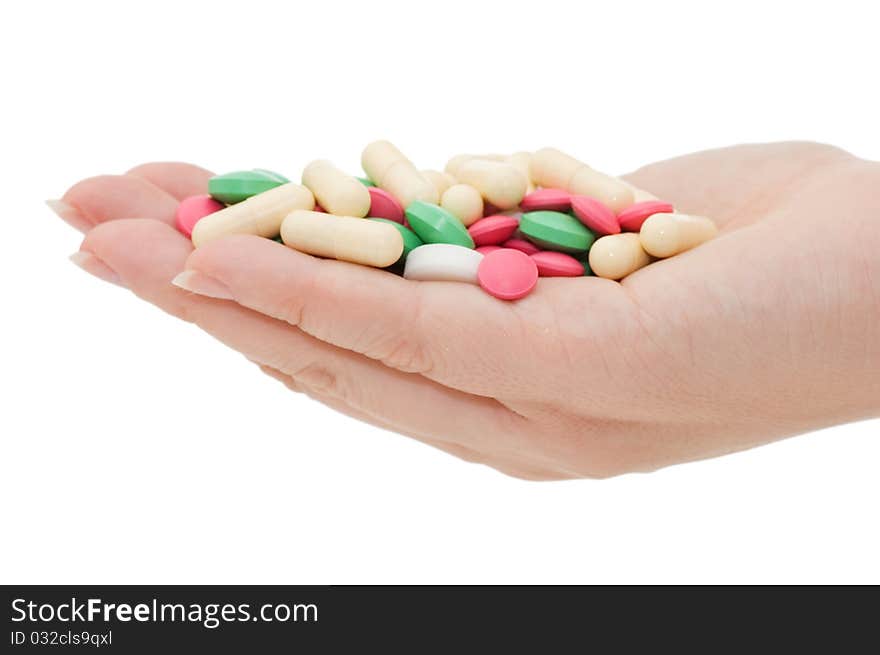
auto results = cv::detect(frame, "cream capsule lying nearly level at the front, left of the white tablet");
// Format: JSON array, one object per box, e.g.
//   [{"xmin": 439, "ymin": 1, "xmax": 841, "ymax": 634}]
[{"xmin": 281, "ymin": 210, "xmax": 403, "ymax": 268}]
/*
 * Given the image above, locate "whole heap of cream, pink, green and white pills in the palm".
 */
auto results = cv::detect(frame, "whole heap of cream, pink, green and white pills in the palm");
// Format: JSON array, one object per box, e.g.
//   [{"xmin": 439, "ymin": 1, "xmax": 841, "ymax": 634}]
[{"xmin": 177, "ymin": 141, "xmax": 717, "ymax": 300}]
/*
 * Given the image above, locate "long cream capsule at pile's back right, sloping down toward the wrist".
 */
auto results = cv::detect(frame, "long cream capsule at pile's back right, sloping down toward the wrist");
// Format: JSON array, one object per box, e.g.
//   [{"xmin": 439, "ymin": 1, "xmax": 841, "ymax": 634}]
[{"xmin": 529, "ymin": 148, "xmax": 633, "ymax": 212}]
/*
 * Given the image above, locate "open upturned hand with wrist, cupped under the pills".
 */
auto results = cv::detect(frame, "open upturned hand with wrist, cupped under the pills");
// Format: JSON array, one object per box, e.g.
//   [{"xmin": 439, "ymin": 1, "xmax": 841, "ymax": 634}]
[{"xmin": 56, "ymin": 143, "xmax": 880, "ymax": 480}]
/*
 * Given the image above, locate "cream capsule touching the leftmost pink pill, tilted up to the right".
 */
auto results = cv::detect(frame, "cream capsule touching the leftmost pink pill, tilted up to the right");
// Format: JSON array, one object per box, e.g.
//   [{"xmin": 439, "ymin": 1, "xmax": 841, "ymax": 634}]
[{"xmin": 192, "ymin": 182, "xmax": 315, "ymax": 248}]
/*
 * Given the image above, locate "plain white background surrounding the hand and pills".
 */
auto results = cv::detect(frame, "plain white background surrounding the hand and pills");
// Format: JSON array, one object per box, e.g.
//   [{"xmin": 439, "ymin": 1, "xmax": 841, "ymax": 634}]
[{"xmin": 0, "ymin": 0, "xmax": 880, "ymax": 583}]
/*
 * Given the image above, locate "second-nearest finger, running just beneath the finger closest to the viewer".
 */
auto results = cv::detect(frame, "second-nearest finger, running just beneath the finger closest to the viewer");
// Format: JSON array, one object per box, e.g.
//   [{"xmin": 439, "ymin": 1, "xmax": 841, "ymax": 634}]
[{"xmin": 82, "ymin": 219, "xmax": 524, "ymax": 448}]
